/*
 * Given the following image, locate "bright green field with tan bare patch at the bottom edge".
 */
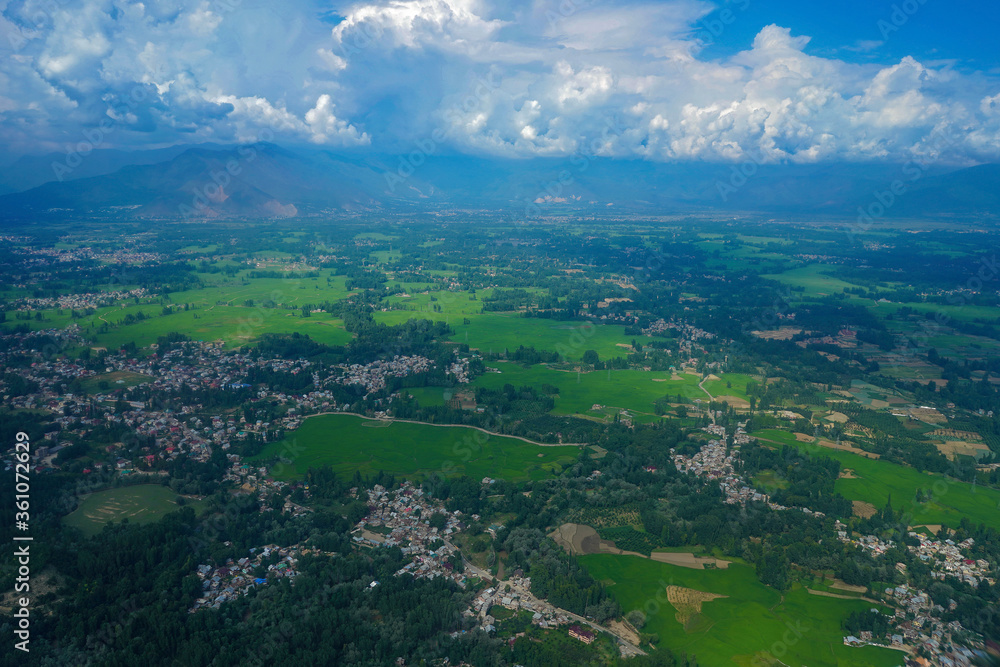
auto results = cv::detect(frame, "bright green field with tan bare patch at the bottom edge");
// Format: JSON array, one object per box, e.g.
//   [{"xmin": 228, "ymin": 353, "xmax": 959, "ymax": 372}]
[{"xmin": 579, "ymin": 554, "xmax": 904, "ymax": 667}]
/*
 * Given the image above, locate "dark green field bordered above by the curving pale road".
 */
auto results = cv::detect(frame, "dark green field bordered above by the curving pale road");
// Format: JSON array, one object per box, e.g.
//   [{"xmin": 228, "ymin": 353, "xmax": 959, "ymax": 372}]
[{"xmin": 256, "ymin": 415, "xmax": 580, "ymax": 481}]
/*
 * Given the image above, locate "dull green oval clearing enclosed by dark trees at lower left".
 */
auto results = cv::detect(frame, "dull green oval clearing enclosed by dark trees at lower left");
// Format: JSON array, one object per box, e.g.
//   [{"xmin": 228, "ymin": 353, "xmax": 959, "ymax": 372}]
[{"xmin": 63, "ymin": 484, "xmax": 202, "ymax": 535}]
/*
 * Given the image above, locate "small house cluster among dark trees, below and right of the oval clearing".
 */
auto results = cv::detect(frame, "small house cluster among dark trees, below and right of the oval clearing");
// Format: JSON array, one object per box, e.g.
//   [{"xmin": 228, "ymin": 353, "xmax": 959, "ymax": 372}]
[{"xmin": 188, "ymin": 544, "xmax": 299, "ymax": 614}]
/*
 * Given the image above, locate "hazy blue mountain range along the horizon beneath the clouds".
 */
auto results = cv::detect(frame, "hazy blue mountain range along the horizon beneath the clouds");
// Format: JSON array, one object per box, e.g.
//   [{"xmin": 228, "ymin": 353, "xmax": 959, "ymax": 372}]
[{"xmin": 0, "ymin": 143, "xmax": 1000, "ymax": 220}]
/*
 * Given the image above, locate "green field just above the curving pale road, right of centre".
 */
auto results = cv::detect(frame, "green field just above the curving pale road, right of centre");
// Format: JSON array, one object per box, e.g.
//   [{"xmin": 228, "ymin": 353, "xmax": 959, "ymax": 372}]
[{"xmin": 475, "ymin": 362, "xmax": 704, "ymax": 414}]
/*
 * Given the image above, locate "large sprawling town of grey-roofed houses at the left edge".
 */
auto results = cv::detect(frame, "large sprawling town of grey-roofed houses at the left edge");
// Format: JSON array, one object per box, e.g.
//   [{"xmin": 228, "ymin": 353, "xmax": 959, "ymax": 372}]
[{"xmin": 0, "ymin": 334, "xmax": 458, "ymax": 475}]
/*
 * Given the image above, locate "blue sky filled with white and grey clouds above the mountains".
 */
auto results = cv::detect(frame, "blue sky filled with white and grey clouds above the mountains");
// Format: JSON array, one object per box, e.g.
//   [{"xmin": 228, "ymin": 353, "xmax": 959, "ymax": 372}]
[{"xmin": 0, "ymin": 0, "xmax": 1000, "ymax": 164}]
